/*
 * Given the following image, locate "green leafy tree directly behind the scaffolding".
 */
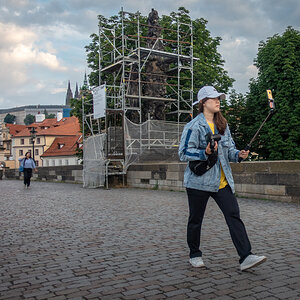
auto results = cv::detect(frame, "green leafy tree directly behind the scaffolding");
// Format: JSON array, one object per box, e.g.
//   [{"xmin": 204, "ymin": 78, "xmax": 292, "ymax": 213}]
[{"xmin": 85, "ymin": 7, "xmax": 234, "ymax": 95}]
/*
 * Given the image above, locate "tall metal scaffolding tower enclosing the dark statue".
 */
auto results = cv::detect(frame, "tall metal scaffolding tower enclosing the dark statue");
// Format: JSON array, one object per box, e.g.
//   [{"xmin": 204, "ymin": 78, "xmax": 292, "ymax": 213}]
[{"xmin": 83, "ymin": 9, "xmax": 198, "ymax": 188}]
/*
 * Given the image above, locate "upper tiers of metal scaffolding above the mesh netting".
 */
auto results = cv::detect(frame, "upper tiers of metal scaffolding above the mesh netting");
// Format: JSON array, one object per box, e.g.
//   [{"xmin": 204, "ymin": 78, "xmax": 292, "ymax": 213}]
[{"xmin": 99, "ymin": 10, "xmax": 196, "ymax": 123}]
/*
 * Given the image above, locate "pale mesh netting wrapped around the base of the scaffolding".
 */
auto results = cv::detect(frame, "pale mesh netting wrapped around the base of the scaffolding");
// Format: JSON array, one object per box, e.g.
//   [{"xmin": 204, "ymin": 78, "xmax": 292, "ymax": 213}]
[{"xmin": 83, "ymin": 118, "xmax": 185, "ymax": 187}]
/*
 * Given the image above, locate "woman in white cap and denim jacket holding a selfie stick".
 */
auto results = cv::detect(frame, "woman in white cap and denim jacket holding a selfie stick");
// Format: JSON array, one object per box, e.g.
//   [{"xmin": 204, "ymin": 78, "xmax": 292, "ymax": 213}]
[{"xmin": 178, "ymin": 86, "xmax": 266, "ymax": 270}]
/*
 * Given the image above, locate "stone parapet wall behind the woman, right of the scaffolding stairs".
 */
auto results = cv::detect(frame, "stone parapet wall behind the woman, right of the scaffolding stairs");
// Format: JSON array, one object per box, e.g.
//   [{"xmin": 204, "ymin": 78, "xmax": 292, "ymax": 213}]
[{"xmin": 127, "ymin": 161, "xmax": 300, "ymax": 203}]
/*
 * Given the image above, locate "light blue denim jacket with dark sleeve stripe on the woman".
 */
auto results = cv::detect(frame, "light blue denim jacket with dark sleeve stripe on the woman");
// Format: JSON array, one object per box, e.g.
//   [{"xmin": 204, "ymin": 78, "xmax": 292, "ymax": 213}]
[{"xmin": 178, "ymin": 113, "xmax": 239, "ymax": 193}]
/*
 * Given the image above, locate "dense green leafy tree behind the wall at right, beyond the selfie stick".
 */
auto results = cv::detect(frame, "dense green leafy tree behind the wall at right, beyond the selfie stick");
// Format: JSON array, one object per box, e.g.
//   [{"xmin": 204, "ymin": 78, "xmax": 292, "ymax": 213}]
[{"xmin": 240, "ymin": 27, "xmax": 300, "ymax": 160}]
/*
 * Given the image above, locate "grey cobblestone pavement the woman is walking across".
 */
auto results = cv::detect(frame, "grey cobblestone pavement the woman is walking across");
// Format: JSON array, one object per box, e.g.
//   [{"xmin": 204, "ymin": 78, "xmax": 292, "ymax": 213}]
[{"xmin": 0, "ymin": 180, "xmax": 300, "ymax": 300}]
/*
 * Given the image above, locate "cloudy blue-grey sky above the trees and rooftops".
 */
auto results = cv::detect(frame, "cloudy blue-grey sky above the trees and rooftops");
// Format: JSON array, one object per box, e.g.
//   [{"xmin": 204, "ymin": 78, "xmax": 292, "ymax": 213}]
[{"xmin": 0, "ymin": 0, "xmax": 300, "ymax": 108}]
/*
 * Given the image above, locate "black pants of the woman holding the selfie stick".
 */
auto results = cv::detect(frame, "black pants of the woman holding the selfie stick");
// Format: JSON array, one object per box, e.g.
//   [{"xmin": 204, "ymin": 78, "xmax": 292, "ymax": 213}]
[{"xmin": 187, "ymin": 185, "xmax": 251, "ymax": 263}]
